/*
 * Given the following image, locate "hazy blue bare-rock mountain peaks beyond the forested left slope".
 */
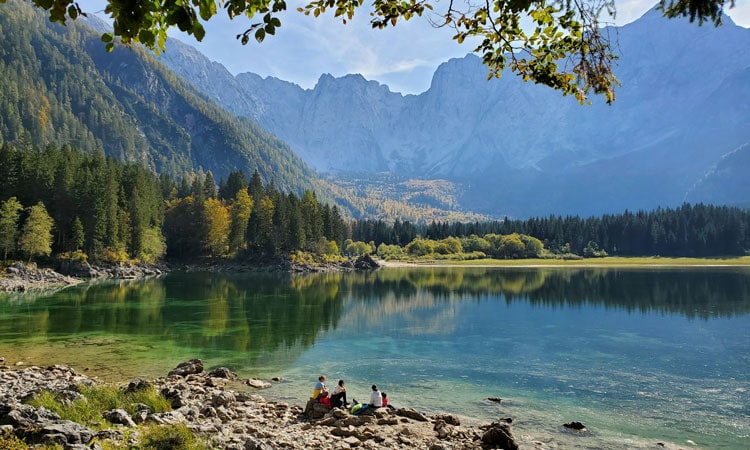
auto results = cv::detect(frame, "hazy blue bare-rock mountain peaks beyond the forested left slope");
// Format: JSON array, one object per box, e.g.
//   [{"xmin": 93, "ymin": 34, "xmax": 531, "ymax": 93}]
[{"xmin": 160, "ymin": 6, "xmax": 750, "ymax": 217}]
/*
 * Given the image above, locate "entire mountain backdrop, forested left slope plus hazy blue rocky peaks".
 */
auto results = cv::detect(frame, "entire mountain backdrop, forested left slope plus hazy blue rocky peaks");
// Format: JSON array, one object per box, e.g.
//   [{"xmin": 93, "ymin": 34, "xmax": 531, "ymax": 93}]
[{"xmin": 0, "ymin": 0, "xmax": 750, "ymax": 220}]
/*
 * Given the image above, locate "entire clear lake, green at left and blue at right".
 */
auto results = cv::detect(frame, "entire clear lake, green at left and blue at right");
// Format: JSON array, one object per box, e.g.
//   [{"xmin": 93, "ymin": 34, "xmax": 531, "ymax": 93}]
[{"xmin": 0, "ymin": 268, "xmax": 750, "ymax": 449}]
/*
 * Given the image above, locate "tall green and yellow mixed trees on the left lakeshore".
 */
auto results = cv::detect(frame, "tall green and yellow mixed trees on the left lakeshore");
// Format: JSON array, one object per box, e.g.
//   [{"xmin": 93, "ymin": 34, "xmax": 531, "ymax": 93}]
[{"xmin": 0, "ymin": 143, "xmax": 349, "ymax": 261}]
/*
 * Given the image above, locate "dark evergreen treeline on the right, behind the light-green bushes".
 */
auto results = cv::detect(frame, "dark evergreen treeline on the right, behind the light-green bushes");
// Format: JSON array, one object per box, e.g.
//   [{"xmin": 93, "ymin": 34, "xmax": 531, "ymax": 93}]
[{"xmin": 352, "ymin": 204, "xmax": 750, "ymax": 257}]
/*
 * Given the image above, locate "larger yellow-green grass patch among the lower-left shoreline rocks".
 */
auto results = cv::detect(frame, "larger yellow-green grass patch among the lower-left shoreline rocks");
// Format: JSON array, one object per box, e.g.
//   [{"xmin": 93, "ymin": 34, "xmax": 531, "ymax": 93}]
[{"xmin": 28, "ymin": 385, "xmax": 172, "ymax": 425}]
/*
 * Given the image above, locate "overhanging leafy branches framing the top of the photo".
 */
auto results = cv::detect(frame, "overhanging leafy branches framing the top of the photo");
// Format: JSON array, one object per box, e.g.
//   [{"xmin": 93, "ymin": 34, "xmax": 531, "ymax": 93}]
[{"xmin": 11, "ymin": 0, "xmax": 734, "ymax": 103}]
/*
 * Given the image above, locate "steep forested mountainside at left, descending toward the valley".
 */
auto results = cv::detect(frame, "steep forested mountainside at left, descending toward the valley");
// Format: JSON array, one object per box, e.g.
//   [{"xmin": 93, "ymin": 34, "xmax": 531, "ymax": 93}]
[{"xmin": 0, "ymin": 0, "xmax": 316, "ymax": 191}]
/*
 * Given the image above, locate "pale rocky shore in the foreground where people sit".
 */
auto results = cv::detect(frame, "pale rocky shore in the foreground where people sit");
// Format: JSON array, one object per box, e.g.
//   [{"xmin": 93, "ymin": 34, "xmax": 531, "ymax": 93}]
[{"xmin": 0, "ymin": 360, "xmax": 520, "ymax": 450}]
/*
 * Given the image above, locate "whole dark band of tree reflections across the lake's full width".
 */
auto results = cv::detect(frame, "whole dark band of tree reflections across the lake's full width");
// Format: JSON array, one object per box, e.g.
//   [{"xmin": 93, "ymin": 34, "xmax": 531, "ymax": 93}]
[{"xmin": 0, "ymin": 268, "xmax": 750, "ymax": 348}]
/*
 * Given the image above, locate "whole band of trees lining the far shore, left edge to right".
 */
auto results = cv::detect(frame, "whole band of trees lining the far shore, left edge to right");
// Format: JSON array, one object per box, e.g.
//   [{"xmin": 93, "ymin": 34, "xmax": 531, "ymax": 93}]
[{"xmin": 0, "ymin": 143, "xmax": 750, "ymax": 261}]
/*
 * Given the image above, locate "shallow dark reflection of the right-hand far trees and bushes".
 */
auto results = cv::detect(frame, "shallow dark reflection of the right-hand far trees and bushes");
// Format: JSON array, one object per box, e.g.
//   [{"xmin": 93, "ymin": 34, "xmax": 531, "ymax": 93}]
[{"xmin": 344, "ymin": 268, "xmax": 750, "ymax": 319}]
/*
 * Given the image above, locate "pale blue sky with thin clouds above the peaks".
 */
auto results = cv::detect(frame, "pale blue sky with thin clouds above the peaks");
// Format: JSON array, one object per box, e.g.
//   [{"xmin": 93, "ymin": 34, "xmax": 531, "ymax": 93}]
[{"xmin": 94, "ymin": 0, "xmax": 750, "ymax": 94}]
